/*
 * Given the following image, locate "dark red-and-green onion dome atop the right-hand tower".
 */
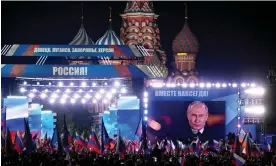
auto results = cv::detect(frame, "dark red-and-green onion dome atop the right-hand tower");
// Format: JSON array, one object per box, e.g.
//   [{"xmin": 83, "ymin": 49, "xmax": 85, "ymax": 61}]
[{"xmin": 172, "ymin": 22, "xmax": 199, "ymax": 53}]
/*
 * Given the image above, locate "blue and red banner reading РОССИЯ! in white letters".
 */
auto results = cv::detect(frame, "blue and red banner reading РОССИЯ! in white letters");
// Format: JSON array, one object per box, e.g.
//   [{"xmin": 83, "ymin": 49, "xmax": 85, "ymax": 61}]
[{"xmin": 1, "ymin": 64, "xmax": 148, "ymax": 78}]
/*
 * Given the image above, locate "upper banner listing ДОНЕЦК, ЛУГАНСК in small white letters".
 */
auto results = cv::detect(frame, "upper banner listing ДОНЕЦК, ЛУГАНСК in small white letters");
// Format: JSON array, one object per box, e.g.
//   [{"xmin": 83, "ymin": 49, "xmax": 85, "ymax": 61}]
[{"xmin": 2, "ymin": 44, "xmax": 142, "ymax": 57}]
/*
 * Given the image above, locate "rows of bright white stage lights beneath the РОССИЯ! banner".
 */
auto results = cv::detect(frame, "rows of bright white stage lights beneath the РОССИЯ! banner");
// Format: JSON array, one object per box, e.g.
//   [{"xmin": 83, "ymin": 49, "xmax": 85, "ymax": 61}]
[{"xmin": 20, "ymin": 80, "xmax": 131, "ymax": 105}]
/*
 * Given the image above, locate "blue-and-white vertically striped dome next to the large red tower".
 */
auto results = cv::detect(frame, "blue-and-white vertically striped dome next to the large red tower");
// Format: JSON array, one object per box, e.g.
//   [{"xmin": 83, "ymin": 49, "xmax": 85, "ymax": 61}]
[{"xmin": 95, "ymin": 24, "xmax": 125, "ymax": 45}]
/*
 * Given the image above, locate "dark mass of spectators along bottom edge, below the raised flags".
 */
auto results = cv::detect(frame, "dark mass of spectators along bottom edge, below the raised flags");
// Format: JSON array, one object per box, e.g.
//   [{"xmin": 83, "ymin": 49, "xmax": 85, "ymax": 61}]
[{"xmin": 1, "ymin": 139, "xmax": 276, "ymax": 166}]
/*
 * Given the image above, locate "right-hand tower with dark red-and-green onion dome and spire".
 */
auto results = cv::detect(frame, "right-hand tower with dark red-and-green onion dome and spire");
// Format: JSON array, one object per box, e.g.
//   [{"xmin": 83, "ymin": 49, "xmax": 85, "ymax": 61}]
[{"xmin": 172, "ymin": 4, "xmax": 199, "ymax": 83}]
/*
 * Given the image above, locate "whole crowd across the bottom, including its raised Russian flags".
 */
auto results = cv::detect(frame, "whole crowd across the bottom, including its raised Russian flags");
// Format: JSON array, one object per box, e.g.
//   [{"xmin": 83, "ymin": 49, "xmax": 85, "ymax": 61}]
[{"xmin": 1, "ymin": 116, "xmax": 276, "ymax": 166}]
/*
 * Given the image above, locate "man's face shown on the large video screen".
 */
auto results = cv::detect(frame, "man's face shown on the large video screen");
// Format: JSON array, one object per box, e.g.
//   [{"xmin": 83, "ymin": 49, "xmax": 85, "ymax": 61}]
[{"xmin": 187, "ymin": 103, "xmax": 208, "ymax": 130}]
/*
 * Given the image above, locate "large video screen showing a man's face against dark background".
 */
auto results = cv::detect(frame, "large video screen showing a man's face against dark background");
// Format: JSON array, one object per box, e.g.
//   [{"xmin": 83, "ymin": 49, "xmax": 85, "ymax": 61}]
[{"xmin": 148, "ymin": 101, "xmax": 225, "ymax": 140}]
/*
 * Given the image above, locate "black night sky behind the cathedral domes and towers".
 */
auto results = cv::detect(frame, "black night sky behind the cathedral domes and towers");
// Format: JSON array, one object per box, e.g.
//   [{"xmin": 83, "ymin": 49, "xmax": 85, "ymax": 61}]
[{"xmin": 1, "ymin": 1, "xmax": 276, "ymax": 126}]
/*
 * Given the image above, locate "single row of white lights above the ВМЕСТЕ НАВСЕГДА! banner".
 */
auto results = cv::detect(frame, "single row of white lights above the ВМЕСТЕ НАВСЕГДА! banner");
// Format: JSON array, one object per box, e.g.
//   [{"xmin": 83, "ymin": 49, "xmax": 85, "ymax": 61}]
[{"xmin": 147, "ymin": 80, "xmax": 256, "ymax": 89}]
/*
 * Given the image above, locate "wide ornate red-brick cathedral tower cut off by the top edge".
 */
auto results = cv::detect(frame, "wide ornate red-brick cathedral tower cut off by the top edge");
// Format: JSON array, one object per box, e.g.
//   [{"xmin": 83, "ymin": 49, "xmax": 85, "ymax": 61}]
[{"xmin": 120, "ymin": 1, "xmax": 167, "ymax": 65}]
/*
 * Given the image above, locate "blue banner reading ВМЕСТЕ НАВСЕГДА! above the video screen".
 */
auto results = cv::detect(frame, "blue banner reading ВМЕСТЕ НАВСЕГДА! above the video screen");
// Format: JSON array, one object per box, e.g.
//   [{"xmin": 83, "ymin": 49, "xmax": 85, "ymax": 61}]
[{"xmin": 148, "ymin": 88, "xmax": 238, "ymax": 101}]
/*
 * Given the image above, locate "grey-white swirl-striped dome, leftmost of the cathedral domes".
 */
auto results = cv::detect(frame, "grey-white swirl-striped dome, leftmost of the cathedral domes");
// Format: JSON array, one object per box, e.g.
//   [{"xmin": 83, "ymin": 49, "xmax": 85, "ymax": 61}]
[{"xmin": 69, "ymin": 24, "xmax": 94, "ymax": 45}]
